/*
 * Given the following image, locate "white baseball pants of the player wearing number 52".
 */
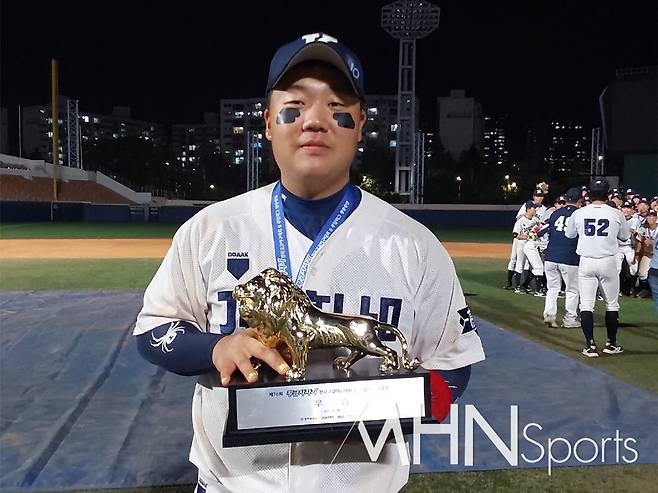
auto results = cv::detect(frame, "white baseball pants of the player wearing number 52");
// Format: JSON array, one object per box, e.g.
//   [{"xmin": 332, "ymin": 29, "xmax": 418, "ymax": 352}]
[{"xmin": 578, "ymin": 255, "xmax": 619, "ymax": 312}]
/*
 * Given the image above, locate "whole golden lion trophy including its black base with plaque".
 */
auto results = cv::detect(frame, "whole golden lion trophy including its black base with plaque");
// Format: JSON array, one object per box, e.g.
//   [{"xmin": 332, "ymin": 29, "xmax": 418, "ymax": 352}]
[{"xmin": 222, "ymin": 268, "xmax": 431, "ymax": 447}]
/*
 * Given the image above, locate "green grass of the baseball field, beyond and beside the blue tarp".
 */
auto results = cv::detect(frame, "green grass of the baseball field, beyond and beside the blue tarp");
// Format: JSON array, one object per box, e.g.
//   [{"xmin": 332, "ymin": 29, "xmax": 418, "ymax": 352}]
[{"xmin": 0, "ymin": 223, "xmax": 658, "ymax": 493}]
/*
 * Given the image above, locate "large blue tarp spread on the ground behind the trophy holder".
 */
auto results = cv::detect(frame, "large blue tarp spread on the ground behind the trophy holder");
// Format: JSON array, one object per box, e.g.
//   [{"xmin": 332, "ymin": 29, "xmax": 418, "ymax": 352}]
[{"xmin": 0, "ymin": 291, "xmax": 658, "ymax": 493}]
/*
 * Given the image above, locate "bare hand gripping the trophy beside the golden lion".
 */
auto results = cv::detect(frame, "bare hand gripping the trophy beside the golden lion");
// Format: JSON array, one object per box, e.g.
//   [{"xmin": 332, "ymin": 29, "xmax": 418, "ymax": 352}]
[{"xmin": 212, "ymin": 328, "xmax": 290, "ymax": 386}]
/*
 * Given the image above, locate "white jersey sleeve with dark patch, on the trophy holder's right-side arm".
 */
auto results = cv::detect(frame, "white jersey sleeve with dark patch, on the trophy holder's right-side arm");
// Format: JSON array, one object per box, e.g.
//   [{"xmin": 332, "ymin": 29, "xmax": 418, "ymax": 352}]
[{"xmin": 410, "ymin": 237, "xmax": 484, "ymax": 370}]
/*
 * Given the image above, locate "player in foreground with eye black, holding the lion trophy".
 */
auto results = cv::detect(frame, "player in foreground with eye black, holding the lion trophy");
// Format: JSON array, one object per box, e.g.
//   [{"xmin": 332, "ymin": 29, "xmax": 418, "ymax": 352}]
[{"xmin": 134, "ymin": 33, "xmax": 484, "ymax": 493}]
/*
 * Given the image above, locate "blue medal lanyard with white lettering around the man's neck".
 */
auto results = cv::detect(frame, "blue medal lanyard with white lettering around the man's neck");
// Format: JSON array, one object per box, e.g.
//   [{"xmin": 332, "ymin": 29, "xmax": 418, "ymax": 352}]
[{"xmin": 270, "ymin": 181, "xmax": 357, "ymax": 288}]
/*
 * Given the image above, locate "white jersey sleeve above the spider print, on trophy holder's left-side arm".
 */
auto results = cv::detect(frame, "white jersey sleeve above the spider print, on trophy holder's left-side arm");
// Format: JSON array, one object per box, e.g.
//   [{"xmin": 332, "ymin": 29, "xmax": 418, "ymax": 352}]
[{"xmin": 133, "ymin": 221, "xmax": 207, "ymax": 335}]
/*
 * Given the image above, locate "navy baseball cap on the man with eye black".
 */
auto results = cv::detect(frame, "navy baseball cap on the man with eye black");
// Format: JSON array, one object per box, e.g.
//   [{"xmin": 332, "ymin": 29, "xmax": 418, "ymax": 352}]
[{"xmin": 265, "ymin": 33, "xmax": 365, "ymax": 101}]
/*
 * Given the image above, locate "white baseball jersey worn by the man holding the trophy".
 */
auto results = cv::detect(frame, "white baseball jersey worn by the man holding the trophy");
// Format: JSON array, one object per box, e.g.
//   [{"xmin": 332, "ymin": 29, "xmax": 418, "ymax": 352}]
[{"xmin": 134, "ymin": 185, "xmax": 484, "ymax": 492}]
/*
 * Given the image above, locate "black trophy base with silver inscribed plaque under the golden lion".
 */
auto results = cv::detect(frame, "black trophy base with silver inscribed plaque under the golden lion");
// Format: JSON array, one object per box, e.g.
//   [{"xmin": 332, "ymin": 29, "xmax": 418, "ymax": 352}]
[{"xmin": 223, "ymin": 349, "xmax": 433, "ymax": 447}]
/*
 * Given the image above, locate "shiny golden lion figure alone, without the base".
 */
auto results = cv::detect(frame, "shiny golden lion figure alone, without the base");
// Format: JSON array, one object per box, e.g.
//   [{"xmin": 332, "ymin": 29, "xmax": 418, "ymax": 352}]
[{"xmin": 233, "ymin": 269, "xmax": 420, "ymax": 381}]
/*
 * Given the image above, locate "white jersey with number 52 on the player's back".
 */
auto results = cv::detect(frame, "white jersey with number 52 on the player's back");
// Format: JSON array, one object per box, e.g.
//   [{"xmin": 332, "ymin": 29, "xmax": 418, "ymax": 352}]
[{"xmin": 564, "ymin": 204, "xmax": 630, "ymax": 258}]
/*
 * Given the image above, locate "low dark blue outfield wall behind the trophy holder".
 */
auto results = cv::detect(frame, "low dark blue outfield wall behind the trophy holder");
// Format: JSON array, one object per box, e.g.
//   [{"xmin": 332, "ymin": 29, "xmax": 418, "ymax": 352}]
[{"xmin": 0, "ymin": 201, "xmax": 518, "ymax": 228}]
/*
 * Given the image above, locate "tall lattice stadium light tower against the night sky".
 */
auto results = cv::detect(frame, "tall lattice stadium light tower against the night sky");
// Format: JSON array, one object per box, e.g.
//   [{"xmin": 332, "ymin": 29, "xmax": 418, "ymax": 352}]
[{"xmin": 381, "ymin": 0, "xmax": 440, "ymax": 202}]
